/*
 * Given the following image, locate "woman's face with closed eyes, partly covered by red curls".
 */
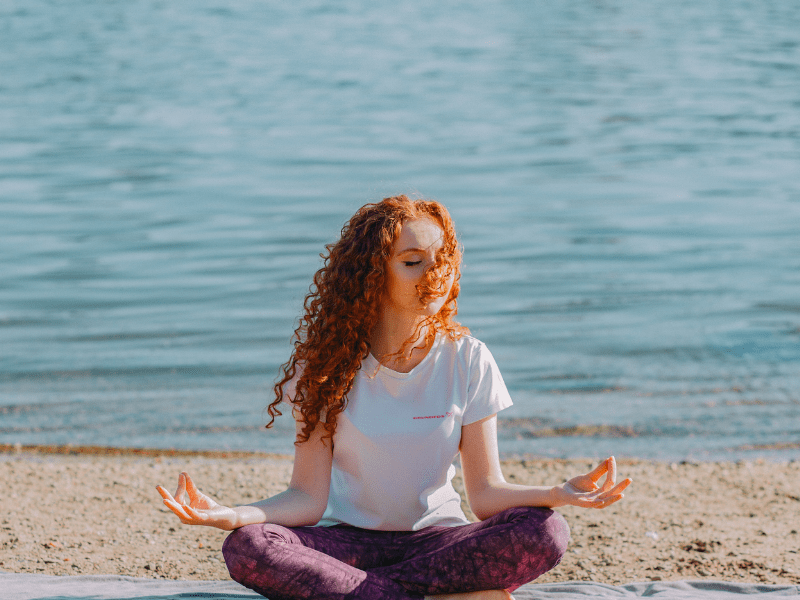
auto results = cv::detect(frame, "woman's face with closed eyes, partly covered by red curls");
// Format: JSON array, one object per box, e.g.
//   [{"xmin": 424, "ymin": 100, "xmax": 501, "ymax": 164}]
[{"xmin": 383, "ymin": 217, "xmax": 453, "ymax": 316}]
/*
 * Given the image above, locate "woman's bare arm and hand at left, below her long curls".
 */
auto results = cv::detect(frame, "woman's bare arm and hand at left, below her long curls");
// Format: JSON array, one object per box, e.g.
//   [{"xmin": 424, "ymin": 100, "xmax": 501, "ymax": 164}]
[{"xmin": 157, "ymin": 408, "xmax": 333, "ymax": 530}]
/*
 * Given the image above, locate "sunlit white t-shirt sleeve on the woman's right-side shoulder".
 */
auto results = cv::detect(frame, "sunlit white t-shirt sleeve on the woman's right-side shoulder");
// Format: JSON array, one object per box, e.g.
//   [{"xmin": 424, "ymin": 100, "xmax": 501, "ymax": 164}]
[{"xmin": 461, "ymin": 342, "xmax": 513, "ymax": 425}]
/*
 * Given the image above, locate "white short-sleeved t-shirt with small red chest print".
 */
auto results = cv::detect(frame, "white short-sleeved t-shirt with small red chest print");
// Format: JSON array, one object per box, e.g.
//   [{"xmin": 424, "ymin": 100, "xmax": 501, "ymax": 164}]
[{"xmin": 318, "ymin": 336, "xmax": 512, "ymax": 531}]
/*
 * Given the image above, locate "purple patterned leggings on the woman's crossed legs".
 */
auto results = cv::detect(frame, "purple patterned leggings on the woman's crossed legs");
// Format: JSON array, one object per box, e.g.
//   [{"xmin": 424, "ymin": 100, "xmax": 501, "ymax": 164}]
[{"xmin": 222, "ymin": 507, "xmax": 569, "ymax": 600}]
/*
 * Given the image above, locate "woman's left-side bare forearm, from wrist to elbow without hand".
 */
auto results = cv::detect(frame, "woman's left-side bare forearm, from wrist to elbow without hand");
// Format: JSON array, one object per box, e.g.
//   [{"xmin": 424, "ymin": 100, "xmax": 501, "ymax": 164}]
[{"xmin": 234, "ymin": 488, "xmax": 325, "ymax": 528}]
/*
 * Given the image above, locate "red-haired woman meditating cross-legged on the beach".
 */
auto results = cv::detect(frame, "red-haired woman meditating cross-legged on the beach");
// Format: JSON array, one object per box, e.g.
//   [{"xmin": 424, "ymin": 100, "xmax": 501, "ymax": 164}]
[{"xmin": 158, "ymin": 196, "xmax": 630, "ymax": 600}]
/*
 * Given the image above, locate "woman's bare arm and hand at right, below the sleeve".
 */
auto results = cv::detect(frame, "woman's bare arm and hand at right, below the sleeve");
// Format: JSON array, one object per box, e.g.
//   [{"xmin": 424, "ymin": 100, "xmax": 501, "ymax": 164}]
[{"xmin": 460, "ymin": 415, "xmax": 631, "ymax": 519}]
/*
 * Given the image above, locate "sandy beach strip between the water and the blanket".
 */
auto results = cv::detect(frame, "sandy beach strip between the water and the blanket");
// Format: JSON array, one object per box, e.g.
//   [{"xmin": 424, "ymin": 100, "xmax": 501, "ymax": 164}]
[{"xmin": 0, "ymin": 446, "xmax": 800, "ymax": 584}]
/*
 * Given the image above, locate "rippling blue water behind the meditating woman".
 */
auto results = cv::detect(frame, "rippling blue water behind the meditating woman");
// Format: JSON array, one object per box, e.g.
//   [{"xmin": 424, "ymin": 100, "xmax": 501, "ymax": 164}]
[{"xmin": 0, "ymin": 0, "xmax": 800, "ymax": 460}]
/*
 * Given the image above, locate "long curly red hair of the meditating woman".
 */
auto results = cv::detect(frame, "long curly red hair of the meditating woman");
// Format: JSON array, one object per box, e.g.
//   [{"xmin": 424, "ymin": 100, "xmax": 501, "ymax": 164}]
[{"xmin": 267, "ymin": 195, "xmax": 469, "ymax": 444}]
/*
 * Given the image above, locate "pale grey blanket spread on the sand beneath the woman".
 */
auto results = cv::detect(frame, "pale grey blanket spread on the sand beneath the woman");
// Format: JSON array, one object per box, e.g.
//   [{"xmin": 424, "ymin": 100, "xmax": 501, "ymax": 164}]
[{"xmin": 0, "ymin": 572, "xmax": 800, "ymax": 600}]
